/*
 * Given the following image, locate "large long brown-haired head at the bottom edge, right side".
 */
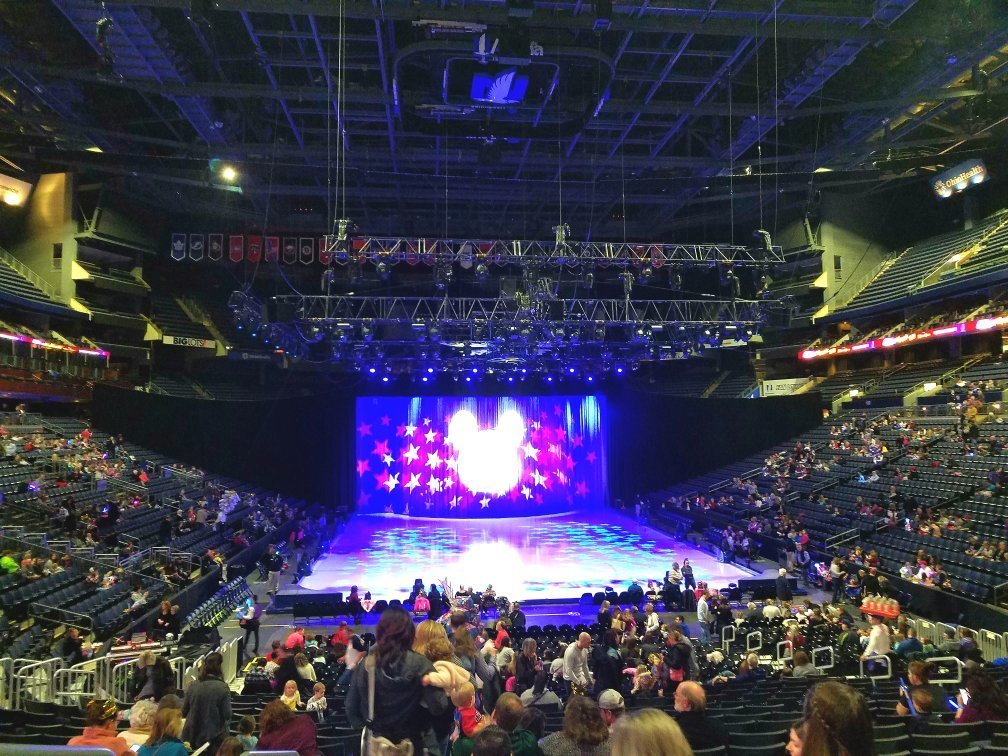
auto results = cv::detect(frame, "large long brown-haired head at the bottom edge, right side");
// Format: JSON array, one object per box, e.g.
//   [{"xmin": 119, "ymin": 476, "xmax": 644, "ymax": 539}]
[{"xmin": 787, "ymin": 680, "xmax": 875, "ymax": 756}]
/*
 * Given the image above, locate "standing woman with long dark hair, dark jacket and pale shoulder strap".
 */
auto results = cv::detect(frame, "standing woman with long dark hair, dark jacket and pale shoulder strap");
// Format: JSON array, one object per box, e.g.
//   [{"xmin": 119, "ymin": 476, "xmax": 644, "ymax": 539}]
[{"xmin": 346, "ymin": 607, "xmax": 452, "ymax": 752}]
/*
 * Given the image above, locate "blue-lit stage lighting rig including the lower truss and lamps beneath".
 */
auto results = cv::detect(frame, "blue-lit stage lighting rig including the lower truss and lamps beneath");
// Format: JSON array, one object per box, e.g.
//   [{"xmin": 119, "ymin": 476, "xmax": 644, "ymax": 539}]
[{"xmin": 264, "ymin": 295, "xmax": 766, "ymax": 376}]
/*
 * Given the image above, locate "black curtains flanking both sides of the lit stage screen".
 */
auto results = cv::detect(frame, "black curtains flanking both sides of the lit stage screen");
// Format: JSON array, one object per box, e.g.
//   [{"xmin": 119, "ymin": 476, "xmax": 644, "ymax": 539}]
[{"xmin": 93, "ymin": 384, "xmax": 823, "ymax": 516}]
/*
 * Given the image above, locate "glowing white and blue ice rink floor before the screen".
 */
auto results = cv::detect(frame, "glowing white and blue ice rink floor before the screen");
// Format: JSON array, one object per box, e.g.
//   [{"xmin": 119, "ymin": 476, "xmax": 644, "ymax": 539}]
[{"xmin": 273, "ymin": 509, "xmax": 761, "ymax": 611}]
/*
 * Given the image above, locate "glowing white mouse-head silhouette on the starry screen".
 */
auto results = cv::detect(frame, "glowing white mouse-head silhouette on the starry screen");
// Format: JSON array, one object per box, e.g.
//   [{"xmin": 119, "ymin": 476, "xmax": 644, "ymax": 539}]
[{"xmin": 448, "ymin": 409, "xmax": 525, "ymax": 496}]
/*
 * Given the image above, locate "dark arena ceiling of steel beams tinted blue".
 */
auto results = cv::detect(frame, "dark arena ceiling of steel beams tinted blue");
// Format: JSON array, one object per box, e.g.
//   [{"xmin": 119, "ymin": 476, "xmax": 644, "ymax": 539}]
[{"xmin": 0, "ymin": 0, "xmax": 1008, "ymax": 244}]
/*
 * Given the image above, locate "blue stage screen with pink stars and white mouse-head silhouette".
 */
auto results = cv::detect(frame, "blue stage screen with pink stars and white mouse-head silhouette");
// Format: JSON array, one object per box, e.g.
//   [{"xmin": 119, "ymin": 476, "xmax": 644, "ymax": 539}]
[{"xmin": 356, "ymin": 395, "xmax": 607, "ymax": 517}]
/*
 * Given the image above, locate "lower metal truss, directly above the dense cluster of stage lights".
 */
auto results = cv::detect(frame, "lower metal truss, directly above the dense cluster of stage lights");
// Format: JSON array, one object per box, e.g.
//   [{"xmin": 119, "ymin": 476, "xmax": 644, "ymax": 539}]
[{"xmin": 272, "ymin": 294, "xmax": 765, "ymax": 327}]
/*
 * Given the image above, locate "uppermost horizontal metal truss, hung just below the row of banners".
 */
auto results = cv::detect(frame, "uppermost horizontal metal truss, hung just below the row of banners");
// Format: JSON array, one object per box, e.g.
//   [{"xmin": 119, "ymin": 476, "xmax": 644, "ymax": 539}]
[{"xmin": 326, "ymin": 236, "xmax": 784, "ymax": 268}]
